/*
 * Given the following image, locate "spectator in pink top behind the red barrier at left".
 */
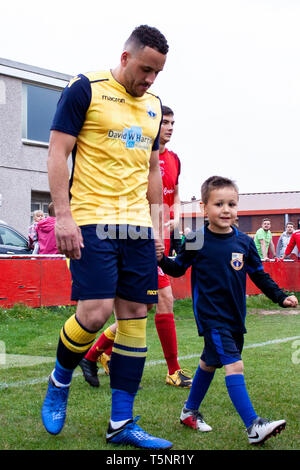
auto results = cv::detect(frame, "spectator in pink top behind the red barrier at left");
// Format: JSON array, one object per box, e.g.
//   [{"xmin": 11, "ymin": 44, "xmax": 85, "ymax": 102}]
[{"xmin": 36, "ymin": 202, "xmax": 59, "ymax": 255}]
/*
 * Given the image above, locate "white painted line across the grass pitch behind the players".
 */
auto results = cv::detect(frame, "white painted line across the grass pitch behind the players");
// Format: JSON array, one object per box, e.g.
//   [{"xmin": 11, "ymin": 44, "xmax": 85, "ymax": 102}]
[{"xmin": 0, "ymin": 336, "xmax": 300, "ymax": 391}]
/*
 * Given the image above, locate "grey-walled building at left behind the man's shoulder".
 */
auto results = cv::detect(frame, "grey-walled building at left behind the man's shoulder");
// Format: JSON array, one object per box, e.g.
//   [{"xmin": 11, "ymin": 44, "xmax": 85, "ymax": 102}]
[{"xmin": 0, "ymin": 58, "xmax": 71, "ymax": 235}]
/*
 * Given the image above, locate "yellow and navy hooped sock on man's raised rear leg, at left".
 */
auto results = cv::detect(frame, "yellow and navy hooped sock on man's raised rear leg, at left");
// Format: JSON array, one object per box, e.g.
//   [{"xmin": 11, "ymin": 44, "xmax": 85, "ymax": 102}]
[{"xmin": 57, "ymin": 314, "xmax": 97, "ymax": 369}]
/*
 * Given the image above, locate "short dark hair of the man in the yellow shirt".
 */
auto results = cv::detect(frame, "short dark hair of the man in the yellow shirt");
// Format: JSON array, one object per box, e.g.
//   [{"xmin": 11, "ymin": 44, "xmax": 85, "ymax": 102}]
[{"xmin": 125, "ymin": 25, "xmax": 169, "ymax": 55}]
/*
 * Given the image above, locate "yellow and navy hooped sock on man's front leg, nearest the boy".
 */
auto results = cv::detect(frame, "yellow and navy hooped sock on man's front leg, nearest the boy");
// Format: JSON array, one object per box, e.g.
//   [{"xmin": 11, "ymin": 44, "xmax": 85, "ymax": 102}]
[{"xmin": 110, "ymin": 317, "xmax": 147, "ymax": 393}]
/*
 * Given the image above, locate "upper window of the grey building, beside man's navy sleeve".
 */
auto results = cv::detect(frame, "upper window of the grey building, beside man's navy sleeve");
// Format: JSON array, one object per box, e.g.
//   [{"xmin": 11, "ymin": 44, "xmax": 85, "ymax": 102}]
[{"xmin": 22, "ymin": 83, "xmax": 61, "ymax": 143}]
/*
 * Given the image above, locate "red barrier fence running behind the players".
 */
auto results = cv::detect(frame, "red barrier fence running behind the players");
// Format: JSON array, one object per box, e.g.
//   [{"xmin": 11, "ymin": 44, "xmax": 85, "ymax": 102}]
[{"xmin": 0, "ymin": 255, "xmax": 300, "ymax": 308}]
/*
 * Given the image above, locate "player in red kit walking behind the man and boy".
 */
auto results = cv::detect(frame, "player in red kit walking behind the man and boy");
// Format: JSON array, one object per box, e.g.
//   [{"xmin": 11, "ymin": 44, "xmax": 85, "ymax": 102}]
[{"xmin": 79, "ymin": 106, "xmax": 192, "ymax": 388}]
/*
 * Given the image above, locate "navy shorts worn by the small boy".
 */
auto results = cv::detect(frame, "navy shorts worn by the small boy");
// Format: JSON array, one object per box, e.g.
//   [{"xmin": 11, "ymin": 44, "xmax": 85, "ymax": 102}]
[{"xmin": 201, "ymin": 328, "xmax": 244, "ymax": 368}]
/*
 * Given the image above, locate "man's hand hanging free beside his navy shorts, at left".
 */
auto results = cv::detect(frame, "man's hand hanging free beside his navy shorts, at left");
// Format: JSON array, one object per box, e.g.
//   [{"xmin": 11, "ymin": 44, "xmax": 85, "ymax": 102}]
[{"xmin": 55, "ymin": 216, "xmax": 84, "ymax": 259}]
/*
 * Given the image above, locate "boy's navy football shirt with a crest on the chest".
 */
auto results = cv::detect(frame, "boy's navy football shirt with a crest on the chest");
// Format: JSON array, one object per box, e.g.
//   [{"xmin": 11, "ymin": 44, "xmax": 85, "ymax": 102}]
[{"xmin": 159, "ymin": 227, "xmax": 263, "ymax": 335}]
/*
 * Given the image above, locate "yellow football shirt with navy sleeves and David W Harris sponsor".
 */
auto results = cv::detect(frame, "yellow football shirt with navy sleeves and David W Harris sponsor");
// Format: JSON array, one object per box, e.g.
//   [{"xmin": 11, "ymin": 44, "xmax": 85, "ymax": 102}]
[{"xmin": 51, "ymin": 71, "xmax": 162, "ymax": 227}]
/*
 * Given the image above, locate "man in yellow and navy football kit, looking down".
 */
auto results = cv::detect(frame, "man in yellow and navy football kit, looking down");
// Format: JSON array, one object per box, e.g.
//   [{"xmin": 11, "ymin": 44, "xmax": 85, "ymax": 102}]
[{"xmin": 42, "ymin": 25, "xmax": 172, "ymax": 449}]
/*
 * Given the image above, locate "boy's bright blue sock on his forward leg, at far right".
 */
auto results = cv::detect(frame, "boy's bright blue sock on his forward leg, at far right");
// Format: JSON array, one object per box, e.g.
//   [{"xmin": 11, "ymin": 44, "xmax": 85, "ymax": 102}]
[{"xmin": 225, "ymin": 374, "xmax": 257, "ymax": 428}]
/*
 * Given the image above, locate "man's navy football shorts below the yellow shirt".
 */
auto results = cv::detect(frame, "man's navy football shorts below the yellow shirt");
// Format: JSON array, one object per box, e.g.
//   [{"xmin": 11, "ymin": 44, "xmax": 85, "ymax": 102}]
[{"xmin": 70, "ymin": 225, "xmax": 158, "ymax": 304}]
